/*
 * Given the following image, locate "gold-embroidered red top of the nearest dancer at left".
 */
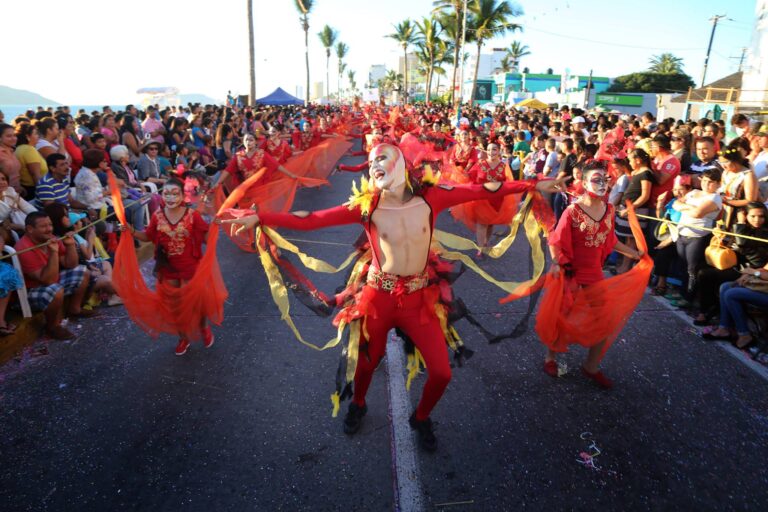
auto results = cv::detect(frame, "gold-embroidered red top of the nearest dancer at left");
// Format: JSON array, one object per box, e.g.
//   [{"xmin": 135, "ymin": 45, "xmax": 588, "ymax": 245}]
[{"xmin": 146, "ymin": 208, "xmax": 208, "ymax": 281}]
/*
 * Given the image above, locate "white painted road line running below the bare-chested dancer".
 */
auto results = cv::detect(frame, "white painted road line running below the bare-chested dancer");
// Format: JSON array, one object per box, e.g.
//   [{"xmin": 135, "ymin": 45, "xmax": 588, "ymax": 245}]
[{"xmin": 387, "ymin": 331, "xmax": 426, "ymax": 512}]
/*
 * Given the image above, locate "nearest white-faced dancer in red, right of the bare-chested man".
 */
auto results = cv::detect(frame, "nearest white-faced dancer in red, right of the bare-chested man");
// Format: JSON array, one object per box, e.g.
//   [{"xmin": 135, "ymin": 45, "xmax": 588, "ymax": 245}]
[{"xmin": 536, "ymin": 162, "xmax": 653, "ymax": 388}]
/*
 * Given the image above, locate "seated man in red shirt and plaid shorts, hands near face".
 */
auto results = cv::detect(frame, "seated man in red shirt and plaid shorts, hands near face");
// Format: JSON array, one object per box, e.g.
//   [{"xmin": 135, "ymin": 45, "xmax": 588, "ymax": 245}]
[{"xmin": 16, "ymin": 212, "xmax": 97, "ymax": 340}]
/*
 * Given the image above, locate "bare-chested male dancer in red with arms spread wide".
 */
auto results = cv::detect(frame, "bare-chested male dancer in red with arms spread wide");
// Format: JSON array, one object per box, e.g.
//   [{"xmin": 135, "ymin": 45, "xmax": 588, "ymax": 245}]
[{"xmin": 224, "ymin": 144, "xmax": 560, "ymax": 451}]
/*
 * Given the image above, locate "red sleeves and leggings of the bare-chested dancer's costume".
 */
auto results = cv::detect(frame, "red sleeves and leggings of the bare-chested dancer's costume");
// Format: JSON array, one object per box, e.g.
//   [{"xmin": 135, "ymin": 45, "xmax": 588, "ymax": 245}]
[{"xmin": 260, "ymin": 182, "xmax": 535, "ymax": 421}]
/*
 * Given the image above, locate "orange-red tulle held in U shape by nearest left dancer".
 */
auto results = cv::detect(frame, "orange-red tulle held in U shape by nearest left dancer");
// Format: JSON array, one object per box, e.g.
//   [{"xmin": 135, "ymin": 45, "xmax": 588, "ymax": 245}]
[{"xmin": 109, "ymin": 172, "xmax": 228, "ymax": 341}]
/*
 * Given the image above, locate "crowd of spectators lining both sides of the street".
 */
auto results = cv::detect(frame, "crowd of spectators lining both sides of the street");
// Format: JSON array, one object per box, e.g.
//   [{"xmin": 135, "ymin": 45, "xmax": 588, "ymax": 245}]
[{"xmin": 0, "ymin": 101, "xmax": 768, "ymax": 354}]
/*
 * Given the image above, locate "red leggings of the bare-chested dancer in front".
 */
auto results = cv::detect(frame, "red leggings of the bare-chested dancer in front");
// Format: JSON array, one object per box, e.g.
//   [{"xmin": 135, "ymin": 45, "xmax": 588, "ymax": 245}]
[{"xmin": 353, "ymin": 289, "xmax": 451, "ymax": 421}]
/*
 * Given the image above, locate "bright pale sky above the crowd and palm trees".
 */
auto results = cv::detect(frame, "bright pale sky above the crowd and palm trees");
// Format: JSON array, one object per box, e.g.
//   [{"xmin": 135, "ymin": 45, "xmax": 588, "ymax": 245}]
[{"xmin": 0, "ymin": 0, "xmax": 755, "ymax": 105}]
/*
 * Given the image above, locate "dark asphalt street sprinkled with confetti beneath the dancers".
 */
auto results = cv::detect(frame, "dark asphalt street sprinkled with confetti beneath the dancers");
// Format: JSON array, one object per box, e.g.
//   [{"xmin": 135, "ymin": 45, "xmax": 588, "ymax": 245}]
[{"xmin": 0, "ymin": 145, "xmax": 768, "ymax": 512}]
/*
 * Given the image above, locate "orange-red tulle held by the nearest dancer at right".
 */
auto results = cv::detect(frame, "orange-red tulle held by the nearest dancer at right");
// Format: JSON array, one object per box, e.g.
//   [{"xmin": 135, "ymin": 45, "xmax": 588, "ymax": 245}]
[{"xmin": 536, "ymin": 205, "xmax": 653, "ymax": 358}]
